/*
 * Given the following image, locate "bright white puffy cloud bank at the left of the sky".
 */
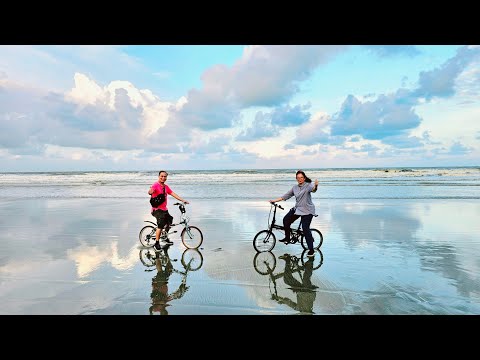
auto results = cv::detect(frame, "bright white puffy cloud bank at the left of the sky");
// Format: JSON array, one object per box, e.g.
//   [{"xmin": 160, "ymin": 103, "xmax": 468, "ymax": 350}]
[{"xmin": 0, "ymin": 73, "xmax": 191, "ymax": 153}]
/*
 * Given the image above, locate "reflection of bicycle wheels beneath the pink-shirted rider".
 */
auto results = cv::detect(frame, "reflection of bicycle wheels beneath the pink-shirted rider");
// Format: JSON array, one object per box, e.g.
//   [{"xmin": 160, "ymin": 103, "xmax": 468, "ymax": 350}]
[{"xmin": 139, "ymin": 245, "xmax": 203, "ymax": 271}]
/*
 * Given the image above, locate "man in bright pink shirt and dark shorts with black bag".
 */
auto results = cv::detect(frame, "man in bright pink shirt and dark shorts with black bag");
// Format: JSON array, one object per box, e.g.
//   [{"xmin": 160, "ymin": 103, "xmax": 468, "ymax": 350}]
[{"xmin": 148, "ymin": 170, "xmax": 189, "ymax": 251}]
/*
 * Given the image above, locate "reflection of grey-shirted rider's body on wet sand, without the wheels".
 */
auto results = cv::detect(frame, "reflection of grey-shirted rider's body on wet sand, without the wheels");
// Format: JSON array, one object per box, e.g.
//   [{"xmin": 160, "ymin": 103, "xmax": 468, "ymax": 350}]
[{"xmin": 274, "ymin": 254, "xmax": 318, "ymax": 314}]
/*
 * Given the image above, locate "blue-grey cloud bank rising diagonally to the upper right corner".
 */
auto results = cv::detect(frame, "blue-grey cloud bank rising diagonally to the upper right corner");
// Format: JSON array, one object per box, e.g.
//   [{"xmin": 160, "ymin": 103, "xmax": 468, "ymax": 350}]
[{"xmin": 330, "ymin": 46, "xmax": 480, "ymax": 148}]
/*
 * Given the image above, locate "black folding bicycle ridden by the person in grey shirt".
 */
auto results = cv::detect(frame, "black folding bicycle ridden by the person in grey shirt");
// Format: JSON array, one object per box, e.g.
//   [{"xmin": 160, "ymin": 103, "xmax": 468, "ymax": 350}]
[{"xmin": 253, "ymin": 203, "xmax": 323, "ymax": 252}]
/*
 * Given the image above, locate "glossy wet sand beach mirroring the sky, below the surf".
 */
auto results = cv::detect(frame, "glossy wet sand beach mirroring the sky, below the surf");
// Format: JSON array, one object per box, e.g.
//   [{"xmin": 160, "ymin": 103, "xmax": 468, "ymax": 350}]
[{"xmin": 0, "ymin": 198, "xmax": 480, "ymax": 315}]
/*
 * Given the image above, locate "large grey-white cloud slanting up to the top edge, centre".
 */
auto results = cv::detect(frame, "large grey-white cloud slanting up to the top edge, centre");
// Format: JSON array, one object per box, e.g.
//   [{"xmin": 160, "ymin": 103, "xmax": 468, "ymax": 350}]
[{"xmin": 177, "ymin": 45, "xmax": 346, "ymax": 130}]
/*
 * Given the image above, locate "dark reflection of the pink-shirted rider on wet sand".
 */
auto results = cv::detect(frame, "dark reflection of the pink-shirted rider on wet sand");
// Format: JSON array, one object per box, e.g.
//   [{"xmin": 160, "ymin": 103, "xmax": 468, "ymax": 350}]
[{"xmin": 150, "ymin": 246, "xmax": 188, "ymax": 315}]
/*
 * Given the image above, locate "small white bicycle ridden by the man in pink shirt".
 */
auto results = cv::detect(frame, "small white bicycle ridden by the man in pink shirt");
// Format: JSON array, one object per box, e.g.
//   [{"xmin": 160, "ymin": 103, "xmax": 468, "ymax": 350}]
[{"xmin": 138, "ymin": 203, "xmax": 203, "ymax": 249}]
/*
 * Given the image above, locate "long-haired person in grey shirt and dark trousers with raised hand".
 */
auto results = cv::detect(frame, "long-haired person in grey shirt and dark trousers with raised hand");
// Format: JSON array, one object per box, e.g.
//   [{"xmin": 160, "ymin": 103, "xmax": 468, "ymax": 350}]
[{"xmin": 270, "ymin": 170, "xmax": 318, "ymax": 256}]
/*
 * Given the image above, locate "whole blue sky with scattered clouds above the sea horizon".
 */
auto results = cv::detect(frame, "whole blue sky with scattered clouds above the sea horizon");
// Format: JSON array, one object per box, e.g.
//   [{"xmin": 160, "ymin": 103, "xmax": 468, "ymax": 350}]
[{"xmin": 0, "ymin": 45, "xmax": 480, "ymax": 172}]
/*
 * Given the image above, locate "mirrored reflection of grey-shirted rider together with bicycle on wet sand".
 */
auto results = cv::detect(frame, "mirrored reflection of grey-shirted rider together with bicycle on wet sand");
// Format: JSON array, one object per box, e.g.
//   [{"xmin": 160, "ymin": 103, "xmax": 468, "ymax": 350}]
[{"xmin": 253, "ymin": 250, "xmax": 323, "ymax": 314}]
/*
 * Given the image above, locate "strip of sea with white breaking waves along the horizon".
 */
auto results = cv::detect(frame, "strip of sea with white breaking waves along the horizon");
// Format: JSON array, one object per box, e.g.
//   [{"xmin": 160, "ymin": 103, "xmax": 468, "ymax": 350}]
[{"xmin": 0, "ymin": 167, "xmax": 480, "ymax": 201}]
